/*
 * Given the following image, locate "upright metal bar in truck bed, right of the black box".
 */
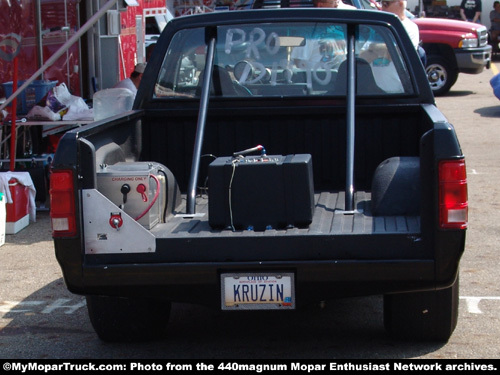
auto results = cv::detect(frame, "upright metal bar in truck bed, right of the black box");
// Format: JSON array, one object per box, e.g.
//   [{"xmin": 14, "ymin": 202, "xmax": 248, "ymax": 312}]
[{"xmin": 345, "ymin": 29, "xmax": 356, "ymax": 212}]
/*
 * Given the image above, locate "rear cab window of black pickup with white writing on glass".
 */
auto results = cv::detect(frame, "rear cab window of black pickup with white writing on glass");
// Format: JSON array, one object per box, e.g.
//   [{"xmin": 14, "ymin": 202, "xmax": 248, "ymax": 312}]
[{"xmin": 154, "ymin": 22, "xmax": 414, "ymax": 99}]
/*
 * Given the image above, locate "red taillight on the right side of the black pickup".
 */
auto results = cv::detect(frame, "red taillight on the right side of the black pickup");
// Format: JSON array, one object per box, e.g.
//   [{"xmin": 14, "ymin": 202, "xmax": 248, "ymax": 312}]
[{"xmin": 439, "ymin": 159, "xmax": 469, "ymax": 229}]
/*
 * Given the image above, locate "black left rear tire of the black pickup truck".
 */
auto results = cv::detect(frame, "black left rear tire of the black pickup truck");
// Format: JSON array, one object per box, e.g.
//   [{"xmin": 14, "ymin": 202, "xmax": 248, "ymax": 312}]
[{"xmin": 86, "ymin": 296, "xmax": 171, "ymax": 342}]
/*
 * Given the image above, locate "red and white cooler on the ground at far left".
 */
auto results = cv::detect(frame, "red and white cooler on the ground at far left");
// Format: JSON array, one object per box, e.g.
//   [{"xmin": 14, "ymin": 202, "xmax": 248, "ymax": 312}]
[{"xmin": 5, "ymin": 178, "xmax": 30, "ymax": 234}]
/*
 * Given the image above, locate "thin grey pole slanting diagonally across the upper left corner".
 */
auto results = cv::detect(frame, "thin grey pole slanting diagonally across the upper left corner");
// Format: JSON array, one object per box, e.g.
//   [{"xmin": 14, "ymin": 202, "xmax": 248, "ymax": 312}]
[{"xmin": 0, "ymin": 0, "xmax": 118, "ymax": 111}]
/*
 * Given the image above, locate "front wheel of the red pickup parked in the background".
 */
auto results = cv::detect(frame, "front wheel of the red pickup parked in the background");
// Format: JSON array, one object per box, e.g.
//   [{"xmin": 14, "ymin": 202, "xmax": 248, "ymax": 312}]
[{"xmin": 425, "ymin": 56, "xmax": 458, "ymax": 96}]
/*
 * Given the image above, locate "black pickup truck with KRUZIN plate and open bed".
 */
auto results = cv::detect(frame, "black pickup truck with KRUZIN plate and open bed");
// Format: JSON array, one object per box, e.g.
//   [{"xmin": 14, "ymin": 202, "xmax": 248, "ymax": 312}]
[{"xmin": 50, "ymin": 9, "xmax": 468, "ymax": 341}]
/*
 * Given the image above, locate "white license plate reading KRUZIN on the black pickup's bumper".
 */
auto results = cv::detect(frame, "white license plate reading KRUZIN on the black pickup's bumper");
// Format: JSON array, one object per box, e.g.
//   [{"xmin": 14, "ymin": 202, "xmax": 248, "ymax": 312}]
[{"xmin": 221, "ymin": 272, "xmax": 295, "ymax": 310}]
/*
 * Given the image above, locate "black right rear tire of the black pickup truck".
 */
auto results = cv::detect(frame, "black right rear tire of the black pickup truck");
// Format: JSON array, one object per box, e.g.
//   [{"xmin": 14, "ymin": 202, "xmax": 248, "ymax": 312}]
[{"xmin": 384, "ymin": 276, "xmax": 459, "ymax": 341}]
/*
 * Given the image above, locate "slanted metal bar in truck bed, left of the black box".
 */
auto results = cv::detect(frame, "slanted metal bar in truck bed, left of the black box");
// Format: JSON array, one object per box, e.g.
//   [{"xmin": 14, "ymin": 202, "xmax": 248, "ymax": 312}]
[{"xmin": 186, "ymin": 36, "xmax": 216, "ymax": 215}]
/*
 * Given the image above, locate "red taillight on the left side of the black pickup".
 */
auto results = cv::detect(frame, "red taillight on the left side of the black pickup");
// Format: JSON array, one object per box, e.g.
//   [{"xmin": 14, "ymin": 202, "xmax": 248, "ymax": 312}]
[{"xmin": 50, "ymin": 170, "xmax": 76, "ymax": 237}]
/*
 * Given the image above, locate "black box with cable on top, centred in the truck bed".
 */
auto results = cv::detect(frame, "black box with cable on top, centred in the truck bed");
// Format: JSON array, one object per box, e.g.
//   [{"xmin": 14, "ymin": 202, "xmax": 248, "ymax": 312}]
[{"xmin": 208, "ymin": 154, "xmax": 314, "ymax": 230}]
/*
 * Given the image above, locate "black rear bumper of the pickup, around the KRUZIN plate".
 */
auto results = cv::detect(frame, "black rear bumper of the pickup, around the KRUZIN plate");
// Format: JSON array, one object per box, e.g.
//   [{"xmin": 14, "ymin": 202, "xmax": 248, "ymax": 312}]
[{"xmin": 72, "ymin": 260, "xmax": 448, "ymax": 306}]
